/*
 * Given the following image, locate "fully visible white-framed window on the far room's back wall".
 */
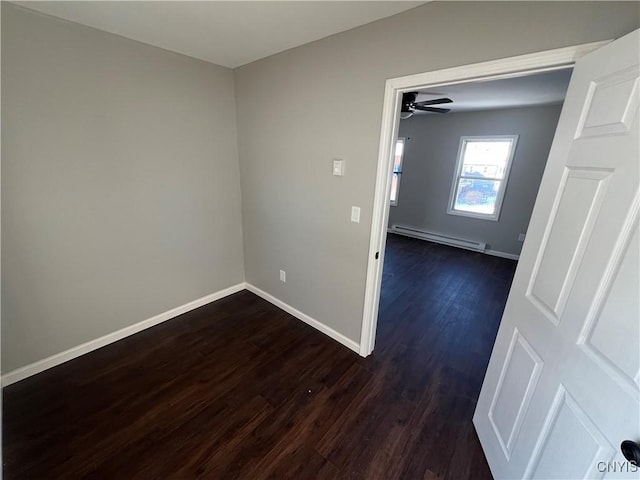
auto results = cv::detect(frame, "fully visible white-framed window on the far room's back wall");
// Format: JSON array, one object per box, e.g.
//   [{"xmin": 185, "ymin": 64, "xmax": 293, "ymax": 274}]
[{"xmin": 447, "ymin": 135, "xmax": 518, "ymax": 220}]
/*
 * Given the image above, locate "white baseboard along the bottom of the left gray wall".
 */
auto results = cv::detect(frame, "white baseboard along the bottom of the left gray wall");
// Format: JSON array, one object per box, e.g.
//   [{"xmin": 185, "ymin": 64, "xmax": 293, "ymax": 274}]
[{"xmin": 2, "ymin": 282, "xmax": 246, "ymax": 387}]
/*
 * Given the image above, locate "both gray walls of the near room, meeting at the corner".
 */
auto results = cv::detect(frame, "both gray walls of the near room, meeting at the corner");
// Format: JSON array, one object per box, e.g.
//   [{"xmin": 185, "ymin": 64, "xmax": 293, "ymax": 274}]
[{"xmin": 2, "ymin": 2, "xmax": 640, "ymax": 372}]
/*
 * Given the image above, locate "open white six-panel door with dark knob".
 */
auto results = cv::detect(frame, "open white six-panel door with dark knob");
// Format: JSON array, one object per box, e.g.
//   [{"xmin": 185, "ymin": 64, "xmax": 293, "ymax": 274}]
[{"xmin": 473, "ymin": 31, "xmax": 640, "ymax": 480}]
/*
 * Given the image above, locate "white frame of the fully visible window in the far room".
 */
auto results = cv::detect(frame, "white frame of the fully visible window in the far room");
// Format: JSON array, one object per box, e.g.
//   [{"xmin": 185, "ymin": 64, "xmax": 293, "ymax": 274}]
[{"xmin": 447, "ymin": 135, "xmax": 518, "ymax": 222}]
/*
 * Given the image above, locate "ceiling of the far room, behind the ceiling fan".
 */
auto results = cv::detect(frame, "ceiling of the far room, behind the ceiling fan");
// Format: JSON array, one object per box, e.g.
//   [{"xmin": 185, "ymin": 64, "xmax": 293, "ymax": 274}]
[{"xmin": 415, "ymin": 68, "xmax": 572, "ymax": 115}]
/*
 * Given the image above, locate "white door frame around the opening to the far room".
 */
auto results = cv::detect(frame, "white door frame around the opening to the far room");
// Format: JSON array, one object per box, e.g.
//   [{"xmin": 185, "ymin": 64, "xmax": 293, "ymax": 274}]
[{"xmin": 359, "ymin": 40, "xmax": 612, "ymax": 357}]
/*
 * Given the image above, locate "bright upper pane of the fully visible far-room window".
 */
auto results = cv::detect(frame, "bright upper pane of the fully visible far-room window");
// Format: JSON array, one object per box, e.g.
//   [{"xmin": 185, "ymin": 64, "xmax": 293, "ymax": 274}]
[{"xmin": 461, "ymin": 140, "xmax": 512, "ymax": 179}]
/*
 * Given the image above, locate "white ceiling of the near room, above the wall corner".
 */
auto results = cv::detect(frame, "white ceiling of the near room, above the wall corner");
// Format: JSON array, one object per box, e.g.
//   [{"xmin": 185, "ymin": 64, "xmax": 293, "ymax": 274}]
[{"xmin": 15, "ymin": 1, "xmax": 426, "ymax": 68}]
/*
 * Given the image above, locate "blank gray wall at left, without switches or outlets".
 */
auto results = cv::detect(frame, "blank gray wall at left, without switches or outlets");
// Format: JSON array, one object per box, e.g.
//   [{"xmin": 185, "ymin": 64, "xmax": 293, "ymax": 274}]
[{"xmin": 2, "ymin": 2, "xmax": 244, "ymax": 372}]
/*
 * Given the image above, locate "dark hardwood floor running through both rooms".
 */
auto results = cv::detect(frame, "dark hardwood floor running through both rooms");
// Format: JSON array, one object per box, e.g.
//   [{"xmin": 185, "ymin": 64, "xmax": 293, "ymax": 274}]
[{"xmin": 3, "ymin": 235, "xmax": 515, "ymax": 480}]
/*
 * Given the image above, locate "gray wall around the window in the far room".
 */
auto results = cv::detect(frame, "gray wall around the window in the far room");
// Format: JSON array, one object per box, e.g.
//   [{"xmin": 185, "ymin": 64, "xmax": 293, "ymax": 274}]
[{"xmin": 389, "ymin": 105, "xmax": 561, "ymax": 255}]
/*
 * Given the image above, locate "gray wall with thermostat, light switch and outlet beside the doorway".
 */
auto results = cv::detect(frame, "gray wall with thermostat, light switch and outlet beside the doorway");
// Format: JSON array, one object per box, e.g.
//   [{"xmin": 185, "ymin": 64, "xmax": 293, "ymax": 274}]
[{"xmin": 235, "ymin": 2, "xmax": 640, "ymax": 341}]
